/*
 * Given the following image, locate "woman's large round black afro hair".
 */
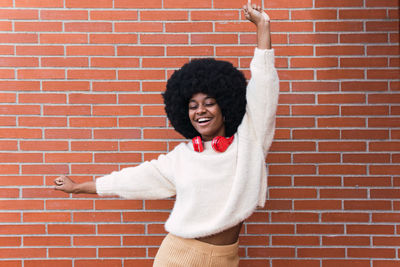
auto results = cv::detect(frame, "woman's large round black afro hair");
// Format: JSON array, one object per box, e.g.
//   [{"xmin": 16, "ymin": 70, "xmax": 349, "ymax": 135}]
[{"xmin": 163, "ymin": 58, "xmax": 247, "ymax": 139}]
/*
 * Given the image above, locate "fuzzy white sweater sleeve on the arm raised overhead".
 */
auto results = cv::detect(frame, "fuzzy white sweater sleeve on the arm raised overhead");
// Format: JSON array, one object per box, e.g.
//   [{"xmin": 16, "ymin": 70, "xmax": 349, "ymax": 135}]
[{"xmin": 246, "ymin": 48, "xmax": 279, "ymax": 154}]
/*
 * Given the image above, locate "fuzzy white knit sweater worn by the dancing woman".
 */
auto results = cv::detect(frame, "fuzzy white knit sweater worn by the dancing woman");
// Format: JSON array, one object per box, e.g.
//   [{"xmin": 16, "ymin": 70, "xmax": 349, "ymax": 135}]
[{"xmin": 96, "ymin": 48, "xmax": 279, "ymax": 238}]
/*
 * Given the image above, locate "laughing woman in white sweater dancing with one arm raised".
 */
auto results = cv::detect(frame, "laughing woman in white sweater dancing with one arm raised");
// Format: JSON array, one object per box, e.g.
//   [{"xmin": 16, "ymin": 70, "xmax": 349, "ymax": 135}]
[{"xmin": 55, "ymin": 0, "xmax": 279, "ymax": 267}]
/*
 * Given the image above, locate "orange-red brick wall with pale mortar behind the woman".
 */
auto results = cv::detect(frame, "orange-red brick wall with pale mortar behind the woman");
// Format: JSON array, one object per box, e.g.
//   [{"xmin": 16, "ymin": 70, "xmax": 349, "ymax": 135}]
[{"xmin": 0, "ymin": 0, "xmax": 400, "ymax": 267}]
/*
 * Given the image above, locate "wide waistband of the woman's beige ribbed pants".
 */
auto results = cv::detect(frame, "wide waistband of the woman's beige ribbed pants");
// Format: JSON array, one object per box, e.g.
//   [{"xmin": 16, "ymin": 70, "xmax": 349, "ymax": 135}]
[{"xmin": 166, "ymin": 233, "xmax": 239, "ymax": 256}]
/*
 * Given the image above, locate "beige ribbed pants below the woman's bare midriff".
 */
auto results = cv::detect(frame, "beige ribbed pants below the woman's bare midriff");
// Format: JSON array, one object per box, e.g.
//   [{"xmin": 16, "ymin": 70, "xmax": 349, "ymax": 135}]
[{"xmin": 153, "ymin": 234, "xmax": 239, "ymax": 267}]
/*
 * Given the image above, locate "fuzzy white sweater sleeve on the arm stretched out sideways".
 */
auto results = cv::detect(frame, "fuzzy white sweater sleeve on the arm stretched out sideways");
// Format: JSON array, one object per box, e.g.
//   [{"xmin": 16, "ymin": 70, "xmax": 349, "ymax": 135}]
[{"xmin": 96, "ymin": 152, "xmax": 176, "ymax": 199}]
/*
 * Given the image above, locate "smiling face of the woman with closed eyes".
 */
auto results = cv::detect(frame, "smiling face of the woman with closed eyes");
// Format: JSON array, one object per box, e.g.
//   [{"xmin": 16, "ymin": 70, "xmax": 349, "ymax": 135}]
[{"xmin": 189, "ymin": 93, "xmax": 225, "ymax": 141}]
